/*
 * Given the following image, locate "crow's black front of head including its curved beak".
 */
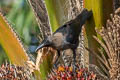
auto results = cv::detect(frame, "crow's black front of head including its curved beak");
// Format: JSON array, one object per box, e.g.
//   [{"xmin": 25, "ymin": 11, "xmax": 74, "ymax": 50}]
[{"xmin": 35, "ymin": 37, "xmax": 52, "ymax": 52}]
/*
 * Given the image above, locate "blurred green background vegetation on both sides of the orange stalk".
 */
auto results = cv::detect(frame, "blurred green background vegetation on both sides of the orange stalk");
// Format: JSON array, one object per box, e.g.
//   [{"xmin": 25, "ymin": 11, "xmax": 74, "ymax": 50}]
[{"xmin": 0, "ymin": 0, "xmax": 39, "ymax": 64}]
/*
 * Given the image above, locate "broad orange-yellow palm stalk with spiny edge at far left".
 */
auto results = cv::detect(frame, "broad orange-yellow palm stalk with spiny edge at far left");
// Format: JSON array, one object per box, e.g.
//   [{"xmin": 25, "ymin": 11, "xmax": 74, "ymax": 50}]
[{"xmin": 0, "ymin": 13, "xmax": 28, "ymax": 66}]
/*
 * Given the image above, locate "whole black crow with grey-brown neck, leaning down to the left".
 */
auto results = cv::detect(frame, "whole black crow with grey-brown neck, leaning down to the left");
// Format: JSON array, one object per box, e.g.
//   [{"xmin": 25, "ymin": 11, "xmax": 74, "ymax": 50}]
[{"xmin": 36, "ymin": 9, "xmax": 92, "ymax": 68}]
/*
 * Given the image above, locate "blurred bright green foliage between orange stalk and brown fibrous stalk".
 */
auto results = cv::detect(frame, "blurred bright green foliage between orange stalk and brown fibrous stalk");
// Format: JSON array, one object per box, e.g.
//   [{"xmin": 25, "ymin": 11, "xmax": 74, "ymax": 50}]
[{"xmin": 7, "ymin": 0, "xmax": 37, "ymax": 45}]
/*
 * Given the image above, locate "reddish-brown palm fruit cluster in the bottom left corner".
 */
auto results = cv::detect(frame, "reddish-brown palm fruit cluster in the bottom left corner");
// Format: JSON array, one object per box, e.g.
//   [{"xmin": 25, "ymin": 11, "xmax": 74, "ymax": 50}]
[{"xmin": 0, "ymin": 63, "xmax": 31, "ymax": 80}]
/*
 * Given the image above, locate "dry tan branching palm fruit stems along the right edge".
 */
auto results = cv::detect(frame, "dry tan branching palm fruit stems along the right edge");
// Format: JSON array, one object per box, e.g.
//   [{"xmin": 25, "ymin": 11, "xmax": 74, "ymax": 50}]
[{"xmin": 89, "ymin": 8, "xmax": 120, "ymax": 80}]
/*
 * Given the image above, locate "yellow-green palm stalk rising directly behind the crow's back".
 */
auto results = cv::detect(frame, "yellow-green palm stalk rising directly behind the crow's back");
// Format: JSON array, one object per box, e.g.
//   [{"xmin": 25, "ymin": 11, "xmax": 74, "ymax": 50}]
[{"xmin": 45, "ymin": 0, "xmax": 69, "ymax": 32}]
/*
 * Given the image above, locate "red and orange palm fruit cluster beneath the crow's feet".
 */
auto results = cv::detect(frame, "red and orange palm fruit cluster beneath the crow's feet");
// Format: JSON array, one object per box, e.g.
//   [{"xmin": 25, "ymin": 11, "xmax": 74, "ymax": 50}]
[{"xmin": 47, "ymin": 65, "xmax": 98, "ymax": 80}]
